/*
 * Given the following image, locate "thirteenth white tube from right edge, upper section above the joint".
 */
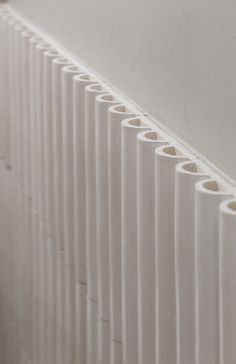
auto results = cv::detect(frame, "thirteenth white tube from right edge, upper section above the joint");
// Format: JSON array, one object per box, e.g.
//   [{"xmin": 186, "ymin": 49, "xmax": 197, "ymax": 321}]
[{"xmin": 43, "ymin": 50, "xmax": 59, "ymax": 237}]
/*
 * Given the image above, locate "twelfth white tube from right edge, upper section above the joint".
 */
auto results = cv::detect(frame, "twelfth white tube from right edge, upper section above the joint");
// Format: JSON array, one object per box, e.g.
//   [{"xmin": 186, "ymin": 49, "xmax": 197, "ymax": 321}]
[{"xmin": 52, "ymin": 57, "xmax": 69, "ymax": 251}]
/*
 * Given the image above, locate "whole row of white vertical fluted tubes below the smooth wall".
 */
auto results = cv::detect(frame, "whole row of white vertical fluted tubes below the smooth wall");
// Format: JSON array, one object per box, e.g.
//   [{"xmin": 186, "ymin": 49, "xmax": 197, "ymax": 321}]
[{"xmin": 0, "ymin": 6, "xmax": 236, "ymax": 364}]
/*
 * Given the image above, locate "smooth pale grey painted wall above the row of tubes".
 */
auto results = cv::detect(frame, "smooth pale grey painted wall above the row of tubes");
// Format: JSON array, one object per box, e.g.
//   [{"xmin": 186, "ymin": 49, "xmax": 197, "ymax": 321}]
[{"xmin": 10, "ymin": 0, "xmax": 236, "ymax": 179}]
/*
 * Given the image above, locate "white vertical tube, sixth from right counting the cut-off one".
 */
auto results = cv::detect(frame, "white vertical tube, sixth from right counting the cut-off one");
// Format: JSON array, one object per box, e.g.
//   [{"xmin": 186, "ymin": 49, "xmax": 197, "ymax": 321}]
[{"xmin": 121, "ymin": 117, "xmax": 149, "ymax": 363}]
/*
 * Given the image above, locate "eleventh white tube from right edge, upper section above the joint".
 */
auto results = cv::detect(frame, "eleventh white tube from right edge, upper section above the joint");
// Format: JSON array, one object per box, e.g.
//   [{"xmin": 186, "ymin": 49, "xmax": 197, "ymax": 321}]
[{"xmin": 62, "ymin": 65, "xmax": 81, "ymax": 266}]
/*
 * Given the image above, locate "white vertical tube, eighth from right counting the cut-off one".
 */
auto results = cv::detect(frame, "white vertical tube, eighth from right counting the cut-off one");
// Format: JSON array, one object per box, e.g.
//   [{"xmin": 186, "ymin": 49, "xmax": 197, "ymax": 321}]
[{"xmin": 95, "ymin": 93, "xmax": 119, "ymax": 364}]
